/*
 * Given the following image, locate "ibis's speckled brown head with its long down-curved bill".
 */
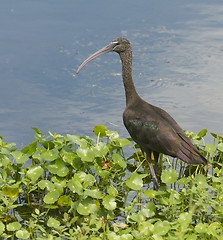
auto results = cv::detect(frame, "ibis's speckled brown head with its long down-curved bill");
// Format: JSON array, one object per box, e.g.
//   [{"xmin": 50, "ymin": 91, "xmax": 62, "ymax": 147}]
[{"xmin": 76, "ymin": 37, "xmax": 131, "ymax": 74}]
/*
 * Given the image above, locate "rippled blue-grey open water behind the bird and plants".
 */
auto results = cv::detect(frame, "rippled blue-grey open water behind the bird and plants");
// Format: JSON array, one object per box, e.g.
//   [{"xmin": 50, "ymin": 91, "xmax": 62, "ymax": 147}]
[{"xmin": 0, "ymin": 0, "xmax": 223, "ymax": 148}]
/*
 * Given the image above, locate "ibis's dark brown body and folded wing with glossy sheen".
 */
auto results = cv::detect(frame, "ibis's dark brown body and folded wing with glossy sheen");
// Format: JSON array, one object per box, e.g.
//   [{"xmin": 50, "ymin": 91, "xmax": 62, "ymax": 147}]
[{"xmin": 123, "ymin": 104, "xmax": 206, "ymax": 164}]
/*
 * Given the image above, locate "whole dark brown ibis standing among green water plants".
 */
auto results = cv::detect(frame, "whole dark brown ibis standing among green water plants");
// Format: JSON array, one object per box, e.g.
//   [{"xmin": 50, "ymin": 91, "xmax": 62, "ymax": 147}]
[{"xmin": 76, "ymin": 38, "xmax": 207, "ymax": 190}]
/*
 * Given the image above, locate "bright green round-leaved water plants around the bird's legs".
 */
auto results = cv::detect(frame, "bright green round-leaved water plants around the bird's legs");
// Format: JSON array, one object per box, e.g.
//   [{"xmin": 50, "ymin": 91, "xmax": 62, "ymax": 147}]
[{"xmin": 0, "ymin": 126, "xmax": 223, "ymax": 240}]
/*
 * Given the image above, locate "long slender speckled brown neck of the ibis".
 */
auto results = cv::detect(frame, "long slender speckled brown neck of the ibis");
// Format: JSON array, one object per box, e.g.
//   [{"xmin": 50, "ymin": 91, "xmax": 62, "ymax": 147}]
[{"xmin": 120, "ymin": 51, "xmax": 139, "ymax": 106}]
